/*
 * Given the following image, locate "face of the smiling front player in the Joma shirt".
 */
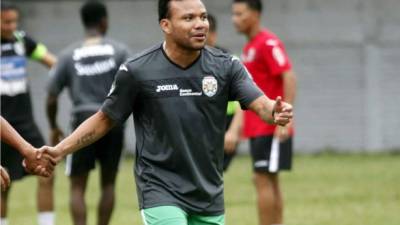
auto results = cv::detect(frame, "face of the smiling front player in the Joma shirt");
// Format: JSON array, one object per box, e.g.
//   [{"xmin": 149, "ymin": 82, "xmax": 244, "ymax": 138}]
[{"xmin": 167, "ymin": 0, "xmax": 209, "ymax": 50}]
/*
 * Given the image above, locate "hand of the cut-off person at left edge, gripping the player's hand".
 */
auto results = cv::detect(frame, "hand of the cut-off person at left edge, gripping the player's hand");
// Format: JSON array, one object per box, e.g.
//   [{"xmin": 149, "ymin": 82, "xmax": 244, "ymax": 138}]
[{"xmin": 23, "ymin": 148, "xmax": 57, "ymax": 177}]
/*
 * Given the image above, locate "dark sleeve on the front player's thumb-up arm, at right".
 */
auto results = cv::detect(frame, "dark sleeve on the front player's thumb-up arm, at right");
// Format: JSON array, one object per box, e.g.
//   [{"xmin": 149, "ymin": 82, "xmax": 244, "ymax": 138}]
[{"xmin": 229, "ymin": 57, "xmax": 263, "ymax": 109}]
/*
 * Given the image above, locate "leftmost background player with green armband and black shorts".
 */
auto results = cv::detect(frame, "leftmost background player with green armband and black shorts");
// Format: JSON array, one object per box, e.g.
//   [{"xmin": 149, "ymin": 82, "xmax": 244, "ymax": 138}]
[{"xmin": 0, "ymin": 1, "xmax": 56, "ymax": 225}]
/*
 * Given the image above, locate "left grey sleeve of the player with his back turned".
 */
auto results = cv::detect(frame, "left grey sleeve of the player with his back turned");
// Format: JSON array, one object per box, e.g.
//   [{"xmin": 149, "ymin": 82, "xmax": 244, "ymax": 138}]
[{"xmin": 47, "ymin": 53, "xmax": 69, "ymax": 96}]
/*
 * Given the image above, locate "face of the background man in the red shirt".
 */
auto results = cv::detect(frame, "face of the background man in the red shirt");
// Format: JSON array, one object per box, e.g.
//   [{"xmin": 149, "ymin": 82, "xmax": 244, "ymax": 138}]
[{"xmin": 232, "ymin": 2, "xmax": 259, "ymax": 33}]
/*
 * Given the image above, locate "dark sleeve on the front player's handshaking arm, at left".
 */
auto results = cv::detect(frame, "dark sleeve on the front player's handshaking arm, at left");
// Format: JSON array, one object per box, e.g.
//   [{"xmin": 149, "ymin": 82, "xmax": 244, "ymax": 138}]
[{"xmin": 101, "ymin": 64, "xmax": 138, "ymax": 124}]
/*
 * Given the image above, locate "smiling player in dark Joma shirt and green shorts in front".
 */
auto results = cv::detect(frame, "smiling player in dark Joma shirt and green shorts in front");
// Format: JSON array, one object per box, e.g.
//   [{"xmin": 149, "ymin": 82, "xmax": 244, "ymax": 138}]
[{"xmin": 39, "ymin": 0, "xmax": 292, "ymax": 225}]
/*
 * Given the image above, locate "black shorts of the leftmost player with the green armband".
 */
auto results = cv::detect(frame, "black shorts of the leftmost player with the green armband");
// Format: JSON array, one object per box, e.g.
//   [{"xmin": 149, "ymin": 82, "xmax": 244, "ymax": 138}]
[{"xmin": 1, "ymin": 121, "xmax": 45, "ymax": 181}]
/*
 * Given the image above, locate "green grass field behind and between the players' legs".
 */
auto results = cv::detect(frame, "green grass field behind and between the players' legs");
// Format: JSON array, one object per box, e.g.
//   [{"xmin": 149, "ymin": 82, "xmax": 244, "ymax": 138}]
[{"xmin": 5, "ymin": 154, "xmax": 400, "ymax": 225}]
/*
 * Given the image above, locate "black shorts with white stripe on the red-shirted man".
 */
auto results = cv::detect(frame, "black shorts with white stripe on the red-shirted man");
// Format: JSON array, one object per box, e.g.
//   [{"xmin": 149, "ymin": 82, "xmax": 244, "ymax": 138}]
[{"xmin": 250, "ymin": 135, "xmax": 293, "ymax": 173}]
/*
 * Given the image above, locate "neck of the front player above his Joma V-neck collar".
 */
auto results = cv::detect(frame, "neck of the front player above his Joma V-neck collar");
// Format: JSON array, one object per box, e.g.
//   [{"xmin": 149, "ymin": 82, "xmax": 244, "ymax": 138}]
[{"xmin": 163, "ymin": 41, "xmax": 200, "ymax": 68}]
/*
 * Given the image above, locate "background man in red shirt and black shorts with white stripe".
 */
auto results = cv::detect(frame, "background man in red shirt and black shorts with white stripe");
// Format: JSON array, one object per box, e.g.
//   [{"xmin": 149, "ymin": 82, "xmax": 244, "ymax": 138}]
[{"xmin": 232, "ymin": 0, "xmax": 296, "ymax": 225}]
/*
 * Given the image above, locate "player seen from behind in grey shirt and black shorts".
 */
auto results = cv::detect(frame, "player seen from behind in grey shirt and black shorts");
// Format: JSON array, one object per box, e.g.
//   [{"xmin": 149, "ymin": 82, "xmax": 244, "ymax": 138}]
[{"xmin": 47, "ymin": 1, "xmax": 129, "ymax": 225}]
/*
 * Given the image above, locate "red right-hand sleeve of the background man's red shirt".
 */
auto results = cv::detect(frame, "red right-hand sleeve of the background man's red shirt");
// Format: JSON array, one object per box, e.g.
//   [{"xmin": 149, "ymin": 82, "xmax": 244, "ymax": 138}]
[{"xmin": 263, "ymin": 39, "xmax": 292, "ymax": 76}]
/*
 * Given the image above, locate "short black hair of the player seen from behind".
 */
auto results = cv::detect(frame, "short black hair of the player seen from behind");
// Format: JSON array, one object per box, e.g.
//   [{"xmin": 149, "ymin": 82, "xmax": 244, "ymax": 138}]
[{"xmin": 81, "ymin": 0, "xmax": 107, "ymax": 28}]
